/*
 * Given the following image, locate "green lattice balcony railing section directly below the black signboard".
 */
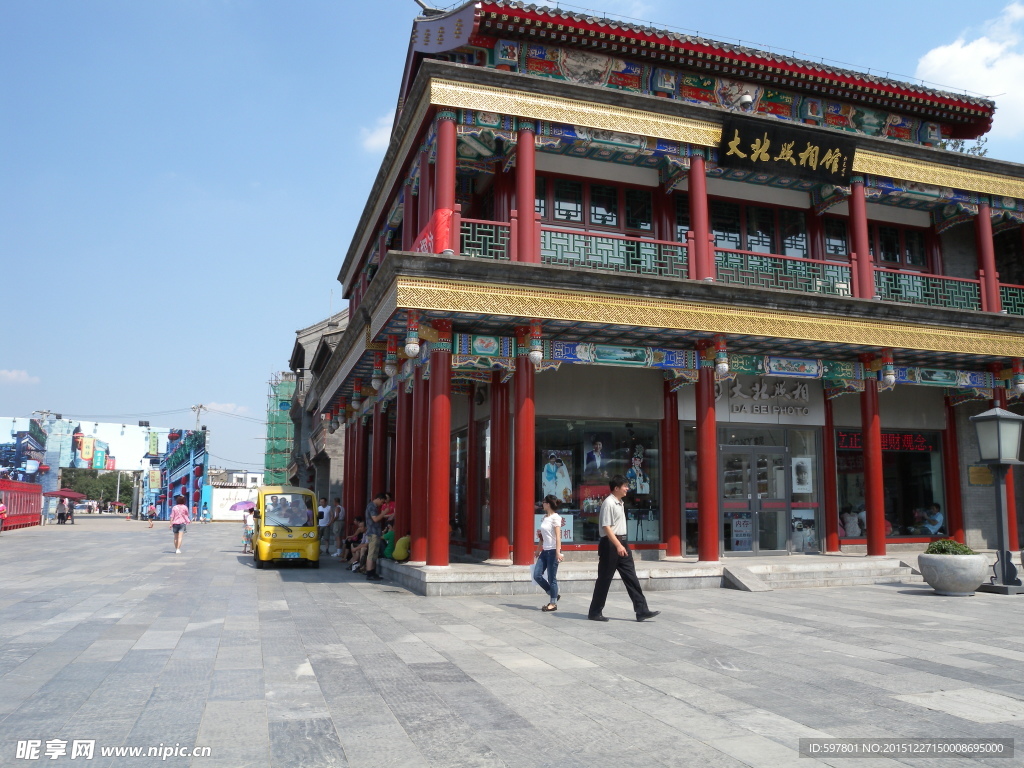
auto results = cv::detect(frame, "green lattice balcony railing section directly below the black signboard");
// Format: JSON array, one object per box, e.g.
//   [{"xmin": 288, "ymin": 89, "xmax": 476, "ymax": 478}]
[{"xmin": 715, "ymin": 249, "xmax": 853, "ymax": 296}]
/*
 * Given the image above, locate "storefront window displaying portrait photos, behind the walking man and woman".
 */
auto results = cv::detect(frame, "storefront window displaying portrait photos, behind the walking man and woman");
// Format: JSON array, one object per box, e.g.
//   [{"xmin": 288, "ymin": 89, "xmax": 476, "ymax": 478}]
[{"xmin": 537, "ymin": 419, "xmax": 662, "ymax": 544}]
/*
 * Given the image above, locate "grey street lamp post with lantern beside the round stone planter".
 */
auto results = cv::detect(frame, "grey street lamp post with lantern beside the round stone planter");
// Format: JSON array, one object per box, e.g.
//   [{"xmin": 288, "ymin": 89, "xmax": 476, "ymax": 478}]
[{"xmin": 971, "ymin": 408, "xmax": 1024, "ymax": 595}]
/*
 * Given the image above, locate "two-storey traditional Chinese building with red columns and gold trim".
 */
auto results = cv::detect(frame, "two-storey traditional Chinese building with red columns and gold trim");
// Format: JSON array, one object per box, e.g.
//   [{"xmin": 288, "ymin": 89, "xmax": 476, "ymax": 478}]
[{"xmin": 319, "ymin": 1, "xmax": 1024, "ymax": 565}]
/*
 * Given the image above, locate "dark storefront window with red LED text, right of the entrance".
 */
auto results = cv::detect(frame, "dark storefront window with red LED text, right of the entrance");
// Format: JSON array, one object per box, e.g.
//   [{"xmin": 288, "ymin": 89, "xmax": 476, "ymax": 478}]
[{"xmin": 836, "ymin": 430, "xmax": 948, "ymax": 539}]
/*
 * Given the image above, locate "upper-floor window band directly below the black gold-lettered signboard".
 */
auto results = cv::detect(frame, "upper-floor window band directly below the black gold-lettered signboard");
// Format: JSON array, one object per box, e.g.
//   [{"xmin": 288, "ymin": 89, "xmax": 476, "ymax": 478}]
[{"xmin": 712, "ymin": 200, "xmax": 809, "ymax": 258}]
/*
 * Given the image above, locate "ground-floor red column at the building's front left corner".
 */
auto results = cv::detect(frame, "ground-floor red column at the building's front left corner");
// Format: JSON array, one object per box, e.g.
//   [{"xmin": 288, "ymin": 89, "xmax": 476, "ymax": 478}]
[{"xmin": 427, "ymin": 321, "xmax": 452, "ymax": 565}]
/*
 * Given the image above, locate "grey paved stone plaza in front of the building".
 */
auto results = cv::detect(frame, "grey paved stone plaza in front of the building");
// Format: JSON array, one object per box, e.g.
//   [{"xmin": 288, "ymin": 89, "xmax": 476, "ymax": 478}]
[{"xmin": 0, "ymin": 516, "xmax": 1024, "ymax": 768}]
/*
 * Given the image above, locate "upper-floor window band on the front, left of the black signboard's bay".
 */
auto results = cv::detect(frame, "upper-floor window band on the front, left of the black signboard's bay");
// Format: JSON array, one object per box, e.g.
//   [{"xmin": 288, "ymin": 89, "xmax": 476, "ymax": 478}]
[{"xmin": 535, "ymin": 176, "xmax": 654, "ymax": 233}]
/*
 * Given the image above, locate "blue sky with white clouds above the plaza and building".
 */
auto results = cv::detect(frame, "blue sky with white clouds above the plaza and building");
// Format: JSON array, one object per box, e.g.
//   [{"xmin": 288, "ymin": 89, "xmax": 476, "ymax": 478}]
[{"xmin": 0, "ymin": 0, "xmax": 1024, "ymax": 468}]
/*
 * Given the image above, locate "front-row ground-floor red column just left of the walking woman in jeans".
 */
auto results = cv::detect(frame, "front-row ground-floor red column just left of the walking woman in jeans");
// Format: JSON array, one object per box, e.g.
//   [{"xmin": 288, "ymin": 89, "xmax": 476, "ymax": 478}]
[{"xmin": 512, "ymin": 328, "xmax": 537, "ymax": 565}]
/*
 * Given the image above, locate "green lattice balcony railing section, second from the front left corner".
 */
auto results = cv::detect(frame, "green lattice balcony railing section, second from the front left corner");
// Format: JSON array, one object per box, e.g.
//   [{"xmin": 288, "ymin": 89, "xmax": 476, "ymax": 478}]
[{"xmin": 541, "ymin": 226, "xmax": 687, "ymax": 278}]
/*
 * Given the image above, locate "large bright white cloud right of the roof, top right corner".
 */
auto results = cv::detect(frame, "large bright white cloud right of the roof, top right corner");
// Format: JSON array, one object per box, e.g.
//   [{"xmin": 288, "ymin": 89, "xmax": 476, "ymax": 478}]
[{"xmin": 915, "ymin": 0, "xmax": 1024, "ymax": 138}]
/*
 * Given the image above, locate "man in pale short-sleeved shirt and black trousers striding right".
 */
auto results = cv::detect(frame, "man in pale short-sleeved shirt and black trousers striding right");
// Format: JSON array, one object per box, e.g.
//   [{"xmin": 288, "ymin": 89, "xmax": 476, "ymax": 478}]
[{"xmin": 587, "ymin": 475, "xmax": 662, "ymax": 622}]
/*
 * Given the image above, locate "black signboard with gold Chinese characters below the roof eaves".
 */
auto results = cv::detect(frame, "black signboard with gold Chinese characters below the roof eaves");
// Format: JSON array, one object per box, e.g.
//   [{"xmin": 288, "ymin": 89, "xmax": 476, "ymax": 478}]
[{"xmin": 718, "ymin": 115, "xmax": 856, "ymax": 184}]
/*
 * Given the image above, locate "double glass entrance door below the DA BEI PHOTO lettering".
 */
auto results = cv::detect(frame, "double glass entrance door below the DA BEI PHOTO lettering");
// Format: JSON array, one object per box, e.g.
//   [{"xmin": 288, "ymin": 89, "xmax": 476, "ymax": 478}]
[{"xmin": 720, "ymin": 445, "xmax": 791, "ymax": 555}]
